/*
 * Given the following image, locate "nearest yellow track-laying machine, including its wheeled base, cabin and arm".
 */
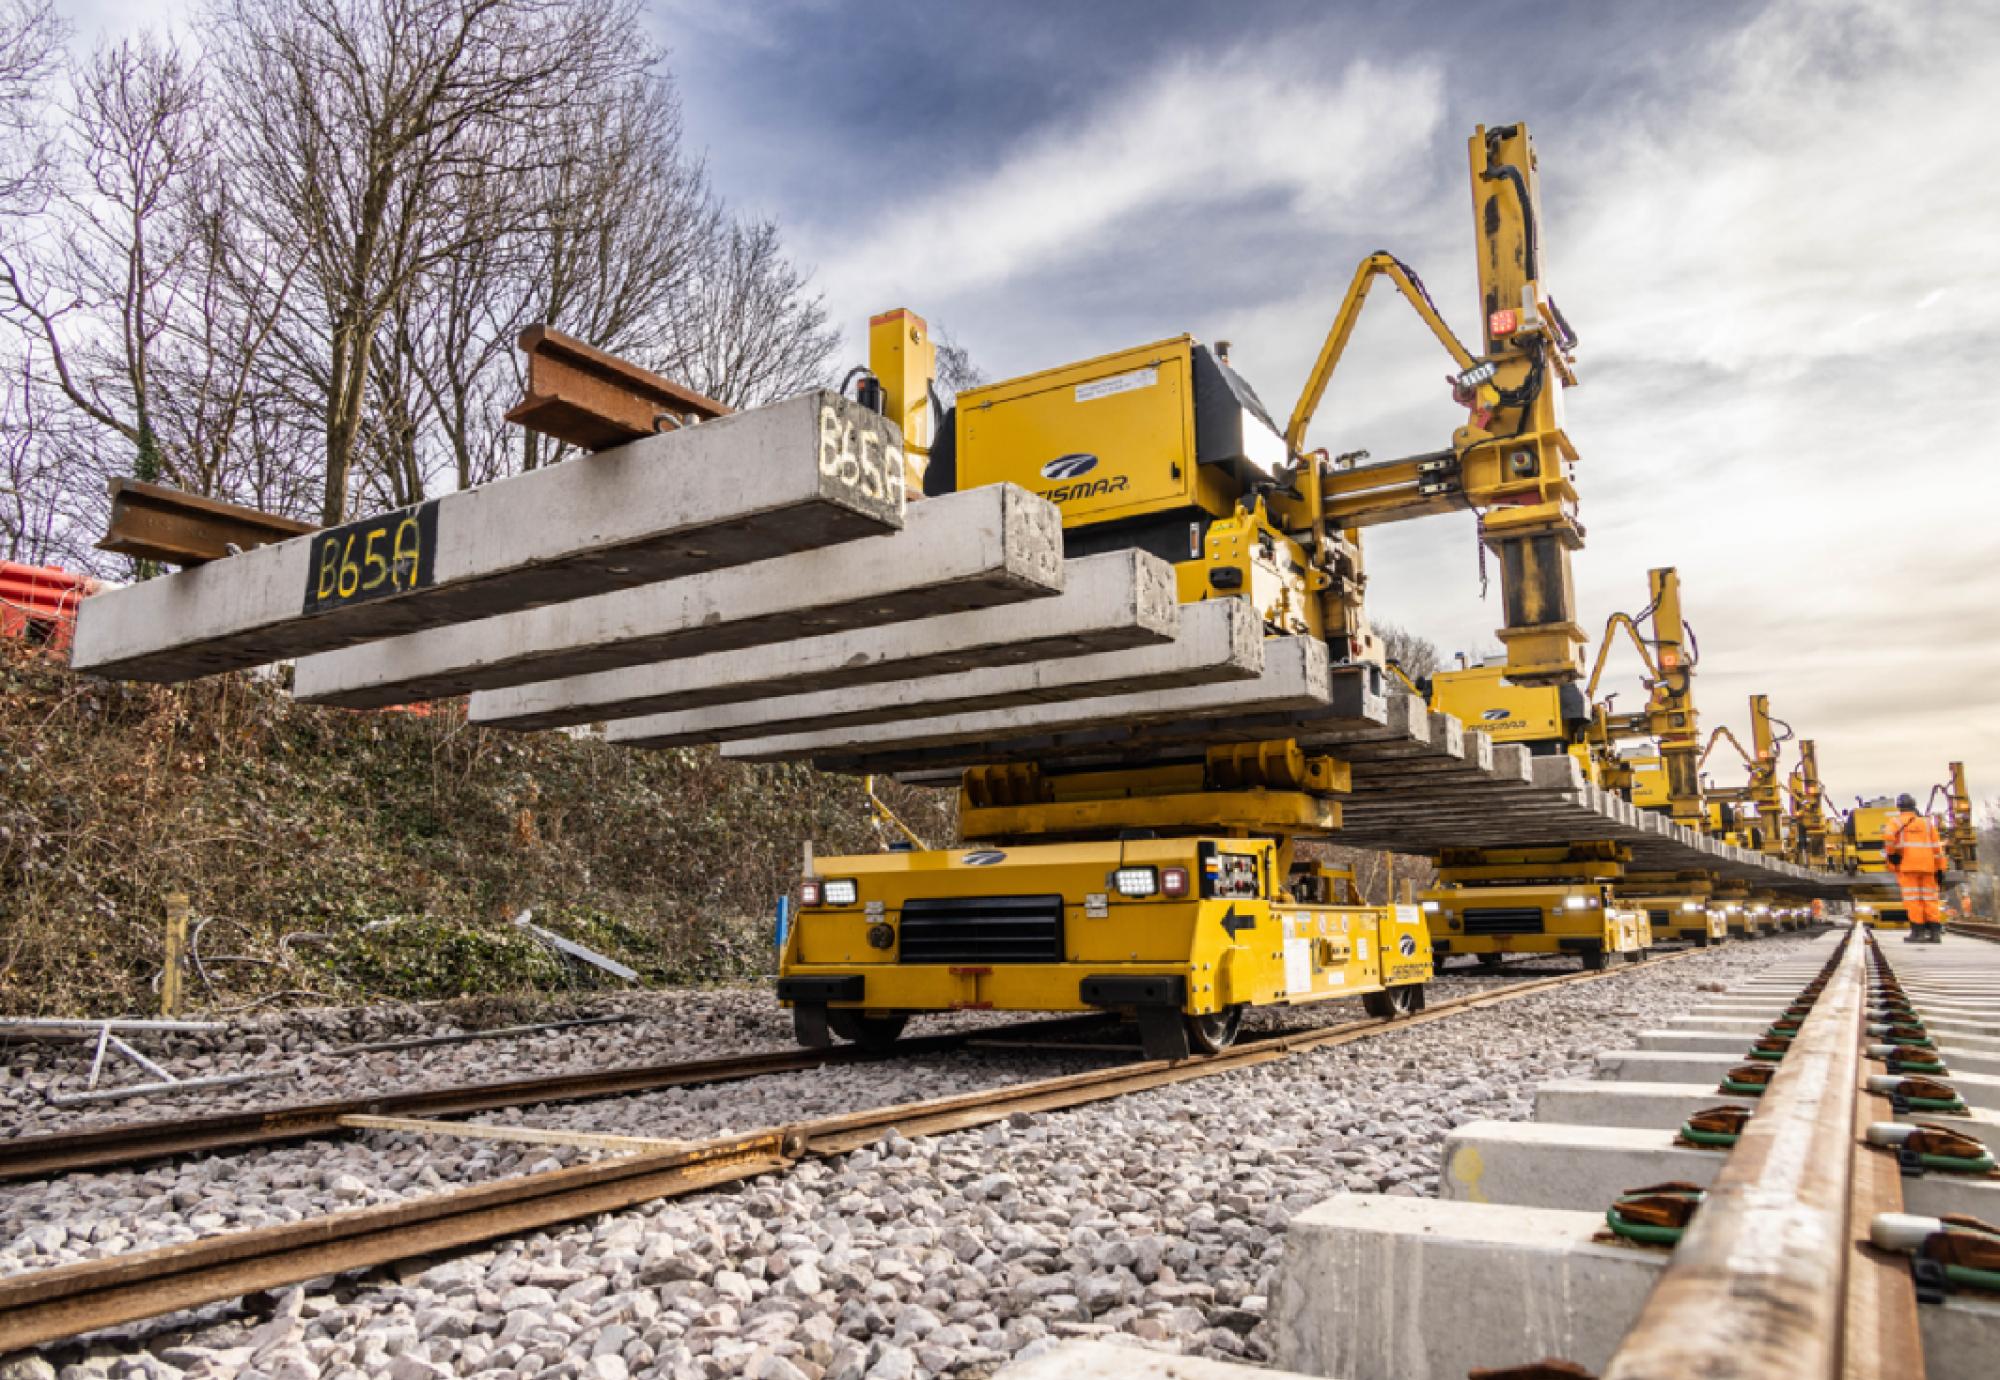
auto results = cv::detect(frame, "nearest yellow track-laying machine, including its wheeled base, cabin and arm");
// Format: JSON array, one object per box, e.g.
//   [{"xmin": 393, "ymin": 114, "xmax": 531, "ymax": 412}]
[{"xmin": 778, "ymin": 124, "xmax": 1582, "ymax": 1058}]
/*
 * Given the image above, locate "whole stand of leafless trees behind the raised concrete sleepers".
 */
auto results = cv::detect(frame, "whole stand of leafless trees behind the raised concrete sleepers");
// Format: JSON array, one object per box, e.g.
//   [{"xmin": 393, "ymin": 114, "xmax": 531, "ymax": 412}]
[{"xmin": 0, "ymin": 0, "xmax": 834, "ymax": 570}]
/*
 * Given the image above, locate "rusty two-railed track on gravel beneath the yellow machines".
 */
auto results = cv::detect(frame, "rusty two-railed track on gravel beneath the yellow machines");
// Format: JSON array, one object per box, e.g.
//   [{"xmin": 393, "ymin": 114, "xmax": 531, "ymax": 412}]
[{"xmin": 0, "ymin": 950, "xmax": 1704, "ymax": 1354}]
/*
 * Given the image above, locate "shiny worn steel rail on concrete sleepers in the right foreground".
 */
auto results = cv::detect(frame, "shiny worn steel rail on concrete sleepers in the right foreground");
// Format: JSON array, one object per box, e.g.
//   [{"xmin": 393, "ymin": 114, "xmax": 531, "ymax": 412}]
[{"xmin": 1604, "ymin": 930, "xmax": 1868, "ymax": 1380}]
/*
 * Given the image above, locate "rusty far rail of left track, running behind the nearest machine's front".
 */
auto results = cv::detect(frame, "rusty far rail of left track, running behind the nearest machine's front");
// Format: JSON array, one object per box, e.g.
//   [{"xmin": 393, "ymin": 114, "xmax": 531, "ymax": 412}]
[{"xmin": 0, "ymin": 1016, "xmax": 1108, "ymax": 1182}]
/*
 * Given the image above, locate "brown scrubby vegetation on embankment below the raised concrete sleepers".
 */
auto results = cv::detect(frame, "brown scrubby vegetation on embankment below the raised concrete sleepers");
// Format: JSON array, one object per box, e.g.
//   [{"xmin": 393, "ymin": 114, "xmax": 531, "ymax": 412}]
[{"xmin": 0, "ymin": 640, "xmax": 950, "ymax": 1016}]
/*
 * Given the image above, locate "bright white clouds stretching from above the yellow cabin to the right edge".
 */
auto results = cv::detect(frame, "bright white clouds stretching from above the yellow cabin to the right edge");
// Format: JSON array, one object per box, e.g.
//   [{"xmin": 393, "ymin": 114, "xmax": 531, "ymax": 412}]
[{"xmin": 806, "ymin": 0, "xmax": 2000, "ymax": 796}]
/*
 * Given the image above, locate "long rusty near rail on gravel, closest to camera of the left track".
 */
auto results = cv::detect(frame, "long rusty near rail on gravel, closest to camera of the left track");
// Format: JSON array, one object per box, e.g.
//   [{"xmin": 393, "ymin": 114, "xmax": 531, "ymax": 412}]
[{"xmin": 0, "ymin": 950, "xmax": 1702, "ymax": 1354}]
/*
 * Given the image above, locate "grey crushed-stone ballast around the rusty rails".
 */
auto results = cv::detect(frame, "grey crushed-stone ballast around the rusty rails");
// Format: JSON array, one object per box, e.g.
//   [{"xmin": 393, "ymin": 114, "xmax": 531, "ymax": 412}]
[{"xmin": 0, "ymin": 938, "xmax": 1804, "ymax": 1380}]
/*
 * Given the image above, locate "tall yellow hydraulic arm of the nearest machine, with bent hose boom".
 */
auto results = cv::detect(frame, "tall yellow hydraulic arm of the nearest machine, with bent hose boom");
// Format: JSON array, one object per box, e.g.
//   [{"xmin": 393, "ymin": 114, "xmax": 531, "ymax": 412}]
[{"xmin": 1286, "ymin": 124, "xmax": 1584, "ymax": 686}]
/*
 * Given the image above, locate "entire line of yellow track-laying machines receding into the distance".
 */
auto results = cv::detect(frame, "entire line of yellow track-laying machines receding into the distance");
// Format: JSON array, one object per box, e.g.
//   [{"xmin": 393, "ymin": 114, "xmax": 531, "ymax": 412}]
[{"xmin": 778, "ymin": 124, "xmax": 1972, "ymax": 1058}]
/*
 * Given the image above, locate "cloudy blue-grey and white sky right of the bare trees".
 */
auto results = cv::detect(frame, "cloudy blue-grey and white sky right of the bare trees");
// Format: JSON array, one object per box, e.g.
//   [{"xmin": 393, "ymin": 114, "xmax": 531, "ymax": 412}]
[{"xmin": 78, "ymin": 0, "xmax": 2000, "ymax": 800}]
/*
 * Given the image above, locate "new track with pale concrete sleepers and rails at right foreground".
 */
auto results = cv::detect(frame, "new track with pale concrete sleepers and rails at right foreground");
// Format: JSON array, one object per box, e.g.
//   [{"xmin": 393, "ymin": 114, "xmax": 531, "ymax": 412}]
[{"xmin": 1276, "ymin": 926, "xmax": 2000, "ymax": 1380}]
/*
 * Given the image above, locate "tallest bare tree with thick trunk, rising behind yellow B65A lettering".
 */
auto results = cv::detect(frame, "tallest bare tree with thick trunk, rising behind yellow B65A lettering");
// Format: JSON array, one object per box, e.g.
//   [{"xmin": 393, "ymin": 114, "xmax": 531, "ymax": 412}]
[{"xmin": 212, "ymin": 0, "xmax": 650, "ymax": 522}]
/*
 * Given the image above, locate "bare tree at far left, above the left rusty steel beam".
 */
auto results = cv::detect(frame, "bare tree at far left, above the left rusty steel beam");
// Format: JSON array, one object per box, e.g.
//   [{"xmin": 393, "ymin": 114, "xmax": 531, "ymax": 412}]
[{"xmin": 0, "ymin": 36, "xmax": 296, "ymax": 548}]
